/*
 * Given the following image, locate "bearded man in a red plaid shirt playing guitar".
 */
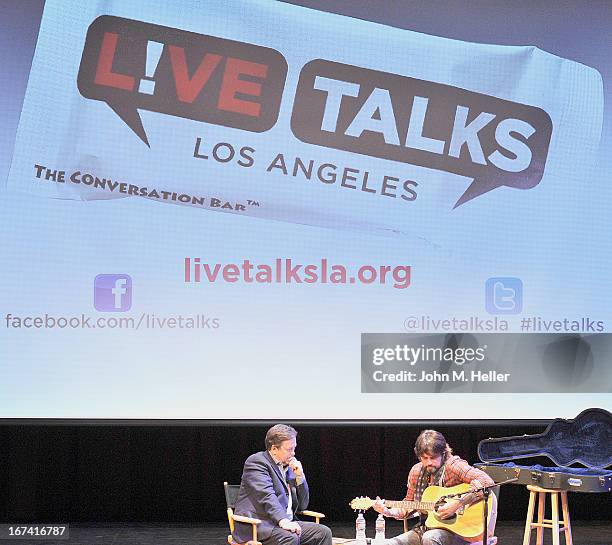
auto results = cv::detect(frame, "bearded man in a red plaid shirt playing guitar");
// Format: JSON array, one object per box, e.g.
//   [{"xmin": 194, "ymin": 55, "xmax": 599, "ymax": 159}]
[{"xmin": 373, "ymin": 430, "xmax": 497, "ymax": 545}]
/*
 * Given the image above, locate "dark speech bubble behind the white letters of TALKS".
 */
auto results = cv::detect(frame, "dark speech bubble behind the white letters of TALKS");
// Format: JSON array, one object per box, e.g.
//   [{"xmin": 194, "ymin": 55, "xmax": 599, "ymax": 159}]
[{"xmin": 291, "ymin": 59, "xmax": 552, "ymax": 208}]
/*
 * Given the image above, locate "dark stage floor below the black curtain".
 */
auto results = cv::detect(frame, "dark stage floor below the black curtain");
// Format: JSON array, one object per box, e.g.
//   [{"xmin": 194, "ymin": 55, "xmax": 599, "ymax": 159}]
[{"xmin": 7, "ymin": 521, "xmax": 612, "ymax": 545}]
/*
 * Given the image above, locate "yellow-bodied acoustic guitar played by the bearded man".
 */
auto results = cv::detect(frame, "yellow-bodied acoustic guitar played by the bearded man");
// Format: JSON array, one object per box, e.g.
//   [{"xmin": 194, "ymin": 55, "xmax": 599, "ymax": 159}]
[{"xmin": 349, "ymin": 484, "xmax": 497, "ymax": 542}]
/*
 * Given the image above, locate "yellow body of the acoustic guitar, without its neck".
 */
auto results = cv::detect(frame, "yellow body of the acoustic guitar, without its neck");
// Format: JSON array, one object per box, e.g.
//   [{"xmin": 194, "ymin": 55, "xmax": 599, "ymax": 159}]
[{"xmin": 421, "ymin": 484, "xmax": 497, "ymax": 542}]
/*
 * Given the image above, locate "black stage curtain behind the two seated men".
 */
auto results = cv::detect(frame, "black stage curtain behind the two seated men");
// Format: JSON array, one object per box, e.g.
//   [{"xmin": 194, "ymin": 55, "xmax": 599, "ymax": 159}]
[{"xmin": 0, "ymin": 424, "xmax": 612, "ymax": 523}]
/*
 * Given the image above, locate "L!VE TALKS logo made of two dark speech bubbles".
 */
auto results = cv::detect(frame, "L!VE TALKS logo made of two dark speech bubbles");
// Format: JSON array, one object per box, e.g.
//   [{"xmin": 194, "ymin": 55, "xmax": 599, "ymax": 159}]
[{"xmin": 78, "ymin": 16, "xmax": 552, "ymax": 207}]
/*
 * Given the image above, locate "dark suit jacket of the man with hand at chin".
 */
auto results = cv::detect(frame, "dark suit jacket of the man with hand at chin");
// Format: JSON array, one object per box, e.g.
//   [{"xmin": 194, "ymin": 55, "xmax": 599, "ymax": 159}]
[{"xmin": 233, "ymin": 451, "xmax": 310, "ymax": 543}]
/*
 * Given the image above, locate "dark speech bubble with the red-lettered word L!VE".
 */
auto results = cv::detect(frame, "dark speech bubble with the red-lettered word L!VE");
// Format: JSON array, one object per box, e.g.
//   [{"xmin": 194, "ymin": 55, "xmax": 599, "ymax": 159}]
[{"xmin": 77, "ymin": 15, "xmax": 287, "ymax": 145}]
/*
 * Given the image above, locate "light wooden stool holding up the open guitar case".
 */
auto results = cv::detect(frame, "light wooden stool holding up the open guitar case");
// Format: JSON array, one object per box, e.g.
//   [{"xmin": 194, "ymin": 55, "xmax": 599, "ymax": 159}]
[{"xmin": 523, "ymin": 484, "xmax": 572, "ymax": 545}]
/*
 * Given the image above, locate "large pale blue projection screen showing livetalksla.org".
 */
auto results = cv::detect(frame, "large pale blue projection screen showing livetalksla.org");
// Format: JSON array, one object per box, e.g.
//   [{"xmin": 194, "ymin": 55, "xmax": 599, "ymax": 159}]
[{"xmin": 0, "ymin": 0, "xmax": 612, "ymax": 420}]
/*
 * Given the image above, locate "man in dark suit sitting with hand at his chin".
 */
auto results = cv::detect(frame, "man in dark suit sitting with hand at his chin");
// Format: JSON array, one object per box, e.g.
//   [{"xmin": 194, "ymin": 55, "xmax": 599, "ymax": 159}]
[{"xmin": 233, "ymin": 424, "xmax": 332, "ymax": 545}]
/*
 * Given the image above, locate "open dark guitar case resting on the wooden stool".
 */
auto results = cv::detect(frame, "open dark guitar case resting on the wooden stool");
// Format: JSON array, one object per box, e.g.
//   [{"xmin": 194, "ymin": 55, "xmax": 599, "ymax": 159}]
[{"xmin": 476, "ymin": 409, "xmax": 612, "ymax": 492}]
